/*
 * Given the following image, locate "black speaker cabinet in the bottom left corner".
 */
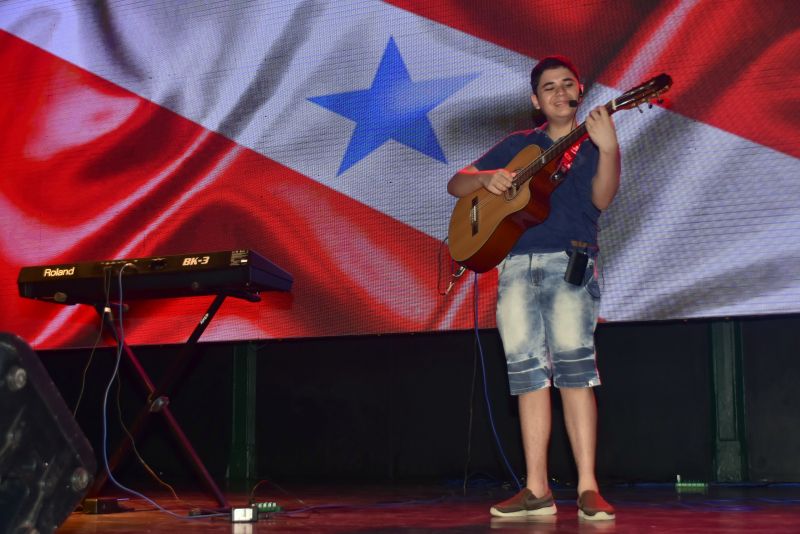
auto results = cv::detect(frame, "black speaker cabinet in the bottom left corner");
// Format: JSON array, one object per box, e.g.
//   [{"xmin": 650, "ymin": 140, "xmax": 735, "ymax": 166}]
[{"xmin": 0, "ymin": 333, "xmax": 97, "ymax": 534}]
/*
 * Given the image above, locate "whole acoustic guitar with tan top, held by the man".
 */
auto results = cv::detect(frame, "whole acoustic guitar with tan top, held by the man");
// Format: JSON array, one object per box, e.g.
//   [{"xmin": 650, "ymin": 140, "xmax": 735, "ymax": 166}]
[{"xmin": 448, "ymin": 74, "xmax": 672, "ymax": 273}]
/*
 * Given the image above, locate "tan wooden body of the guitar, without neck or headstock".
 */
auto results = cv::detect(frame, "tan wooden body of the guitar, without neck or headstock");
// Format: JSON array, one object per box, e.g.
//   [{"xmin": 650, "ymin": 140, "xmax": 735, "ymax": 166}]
[{"xmin": 448, "ymin": 145, "xmax": 563, "ymax": 273}]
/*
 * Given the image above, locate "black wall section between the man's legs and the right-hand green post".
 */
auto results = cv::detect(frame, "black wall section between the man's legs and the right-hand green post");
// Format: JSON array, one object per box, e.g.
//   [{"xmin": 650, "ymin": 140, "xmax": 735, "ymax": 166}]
[{"xmin": 597, "ymin": 322, "xmax": 713, "ymax": 481}]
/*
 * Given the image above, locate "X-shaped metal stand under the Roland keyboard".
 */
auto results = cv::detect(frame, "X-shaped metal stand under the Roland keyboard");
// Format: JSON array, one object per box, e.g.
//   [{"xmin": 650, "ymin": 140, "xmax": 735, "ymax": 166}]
[{"xmin": 88, "ymin": 292, "xmax": 253, "ymax": 511}]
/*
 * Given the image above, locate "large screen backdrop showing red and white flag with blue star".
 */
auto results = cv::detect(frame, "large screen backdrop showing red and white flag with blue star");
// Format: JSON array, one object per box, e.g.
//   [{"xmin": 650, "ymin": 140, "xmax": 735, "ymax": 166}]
[{"xmin": 0, "ymin": 0, "xmax": 800, "ymax": 348}]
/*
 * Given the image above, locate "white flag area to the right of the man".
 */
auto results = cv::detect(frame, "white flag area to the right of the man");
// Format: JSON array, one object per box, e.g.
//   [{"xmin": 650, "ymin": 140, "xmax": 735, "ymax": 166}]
[{"xmin": 601, "ymin": 95, "xmax": 800, "ymax": 320}]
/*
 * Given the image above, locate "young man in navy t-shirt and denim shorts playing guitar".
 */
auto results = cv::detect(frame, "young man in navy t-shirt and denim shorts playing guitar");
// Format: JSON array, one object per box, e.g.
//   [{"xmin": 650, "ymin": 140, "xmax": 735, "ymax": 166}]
[{"xmin": 447, "ymin": 56, "xmax": 620, "ymax": 520}]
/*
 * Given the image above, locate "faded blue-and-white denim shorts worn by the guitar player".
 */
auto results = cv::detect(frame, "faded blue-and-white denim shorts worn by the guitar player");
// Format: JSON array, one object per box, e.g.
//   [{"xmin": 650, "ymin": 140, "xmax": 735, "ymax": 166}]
[{"xmin": 497, "ymin": 252, "xmax": 600, "ymax": 395}]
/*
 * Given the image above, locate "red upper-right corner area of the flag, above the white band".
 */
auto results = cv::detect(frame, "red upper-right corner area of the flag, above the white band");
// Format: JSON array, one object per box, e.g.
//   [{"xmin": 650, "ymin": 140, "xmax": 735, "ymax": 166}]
[{"xmin": 387, "ymin": 0, "xmax": 800, "ymax": 157}]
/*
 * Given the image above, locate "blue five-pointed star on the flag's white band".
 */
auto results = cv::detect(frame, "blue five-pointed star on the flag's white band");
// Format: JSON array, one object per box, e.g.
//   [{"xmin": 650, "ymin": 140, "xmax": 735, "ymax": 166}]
[{"xmin": 309, "ymin": 37, "xmax": 478, "ymax": 176}]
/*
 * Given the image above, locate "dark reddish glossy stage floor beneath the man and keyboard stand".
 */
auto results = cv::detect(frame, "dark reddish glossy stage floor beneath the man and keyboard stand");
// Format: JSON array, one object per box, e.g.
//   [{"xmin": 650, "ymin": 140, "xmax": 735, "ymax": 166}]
[{"xmin": 58, "ymin": 484, "xmax": 800, "ymax": 534}]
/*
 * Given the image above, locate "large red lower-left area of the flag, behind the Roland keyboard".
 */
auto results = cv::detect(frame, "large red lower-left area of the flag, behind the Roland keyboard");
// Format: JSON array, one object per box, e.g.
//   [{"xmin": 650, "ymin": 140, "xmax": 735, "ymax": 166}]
[{"xmin": 0, "ymin": 33, "xmax": 496, "ymax": 348}]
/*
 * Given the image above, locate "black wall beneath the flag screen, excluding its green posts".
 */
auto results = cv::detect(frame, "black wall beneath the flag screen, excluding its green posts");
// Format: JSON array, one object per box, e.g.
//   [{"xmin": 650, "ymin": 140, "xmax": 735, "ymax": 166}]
[{"xmin": 32, "ymin": 318, "xmax": 800, "ymax": 483}]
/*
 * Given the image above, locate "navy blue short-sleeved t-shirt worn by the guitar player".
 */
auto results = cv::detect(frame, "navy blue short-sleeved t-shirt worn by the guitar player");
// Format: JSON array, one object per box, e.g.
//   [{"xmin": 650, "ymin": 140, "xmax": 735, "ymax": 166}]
[{"xmin": 473, "ymin": 129, "xmax": 600, "ymax": 254}]
